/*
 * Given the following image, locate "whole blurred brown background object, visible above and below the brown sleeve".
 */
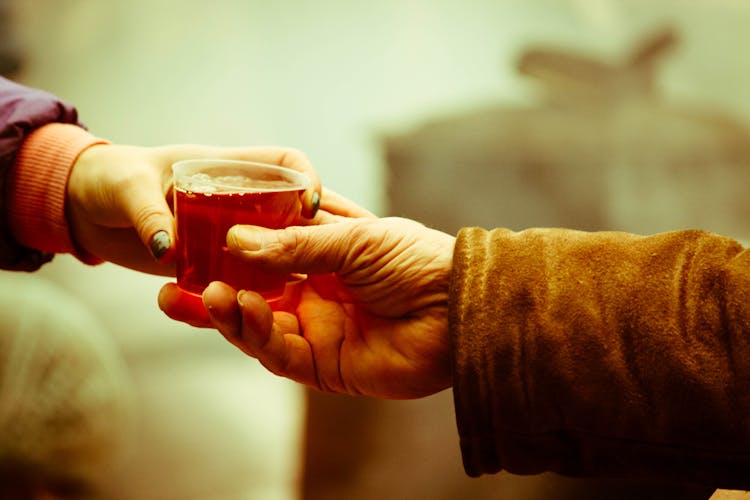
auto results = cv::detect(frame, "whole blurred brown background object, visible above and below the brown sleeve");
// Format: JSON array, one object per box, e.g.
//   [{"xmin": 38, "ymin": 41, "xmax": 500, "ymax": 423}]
[{"xmin": 304, "ymin": 24, "xmax": 750, "ymax": 500}]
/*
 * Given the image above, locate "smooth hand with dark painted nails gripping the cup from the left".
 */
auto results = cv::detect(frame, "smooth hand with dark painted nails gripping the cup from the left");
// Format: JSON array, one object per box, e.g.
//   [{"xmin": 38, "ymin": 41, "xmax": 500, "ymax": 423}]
[{"xmin": 67, "ymin": 145, "xmax": 321, "ymax": 276}]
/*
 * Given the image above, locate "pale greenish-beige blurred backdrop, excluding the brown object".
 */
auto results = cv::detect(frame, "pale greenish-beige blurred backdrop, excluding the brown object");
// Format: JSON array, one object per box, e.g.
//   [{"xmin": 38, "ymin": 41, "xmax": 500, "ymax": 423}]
[{"xmin": 8, "ymin": 0, "xmax": 750, "ymax": 500}]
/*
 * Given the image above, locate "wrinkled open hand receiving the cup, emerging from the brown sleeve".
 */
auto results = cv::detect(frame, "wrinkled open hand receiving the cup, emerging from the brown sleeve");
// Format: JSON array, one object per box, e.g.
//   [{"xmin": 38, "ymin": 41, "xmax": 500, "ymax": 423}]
[{"xmin": 159, "ymin": 196, "xmax": 454, "ymax": 399}]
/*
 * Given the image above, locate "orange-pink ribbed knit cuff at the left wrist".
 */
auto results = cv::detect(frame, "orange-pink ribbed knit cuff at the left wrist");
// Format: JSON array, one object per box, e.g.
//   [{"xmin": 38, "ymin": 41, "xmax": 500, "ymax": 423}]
[{"xmin": 8, "ymin": 123, "xmax": 108, "ymax": 265}]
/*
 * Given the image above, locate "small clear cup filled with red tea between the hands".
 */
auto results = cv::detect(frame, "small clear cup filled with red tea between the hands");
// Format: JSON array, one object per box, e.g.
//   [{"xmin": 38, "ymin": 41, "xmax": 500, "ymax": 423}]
[{"xmin": 172, "ymin": 159, "xmax": 310, "ymax": 300}]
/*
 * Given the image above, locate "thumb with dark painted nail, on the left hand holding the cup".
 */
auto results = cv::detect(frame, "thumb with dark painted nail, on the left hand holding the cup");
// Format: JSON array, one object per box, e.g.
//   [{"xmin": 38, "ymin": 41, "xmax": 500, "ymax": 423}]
[{"xmin": 121, "ymin": 181, "xmax": 174, "ymax": 262}]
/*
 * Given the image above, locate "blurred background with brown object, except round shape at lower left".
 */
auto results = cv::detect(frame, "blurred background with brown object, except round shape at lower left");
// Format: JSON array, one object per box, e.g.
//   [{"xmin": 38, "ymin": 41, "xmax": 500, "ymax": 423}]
[{"xmin": 0, "ymin": 0, "xmax": 750, "ymax": 500}]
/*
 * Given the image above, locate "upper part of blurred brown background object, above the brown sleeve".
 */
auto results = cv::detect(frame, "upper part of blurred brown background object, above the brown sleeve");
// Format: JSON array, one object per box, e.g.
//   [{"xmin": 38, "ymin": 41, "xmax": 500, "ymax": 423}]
[{"xmin": 385, "ymin": 29, "xmax": 750, "ymax": 237}]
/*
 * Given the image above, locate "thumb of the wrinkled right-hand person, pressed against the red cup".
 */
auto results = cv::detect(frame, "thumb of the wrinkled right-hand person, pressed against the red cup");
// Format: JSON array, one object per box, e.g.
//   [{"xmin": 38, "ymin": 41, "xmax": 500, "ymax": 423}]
[{"xmin": 227, "ymin": 222, "xmax": 354, "ymax": 274}]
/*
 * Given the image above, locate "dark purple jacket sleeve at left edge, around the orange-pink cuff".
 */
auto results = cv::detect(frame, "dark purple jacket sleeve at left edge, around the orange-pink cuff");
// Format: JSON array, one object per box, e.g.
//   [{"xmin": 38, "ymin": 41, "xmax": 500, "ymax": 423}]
[{"xmin": 0, "ymin": 77, "xmax": 80, "ymax": 271}]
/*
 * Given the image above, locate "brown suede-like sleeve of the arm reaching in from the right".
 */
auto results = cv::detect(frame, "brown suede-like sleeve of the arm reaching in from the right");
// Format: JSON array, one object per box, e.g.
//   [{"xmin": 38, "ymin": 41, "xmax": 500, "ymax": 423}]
[{"xmin": 450, "ymin": 228, "xmax": 750, "ymax": 489}]
